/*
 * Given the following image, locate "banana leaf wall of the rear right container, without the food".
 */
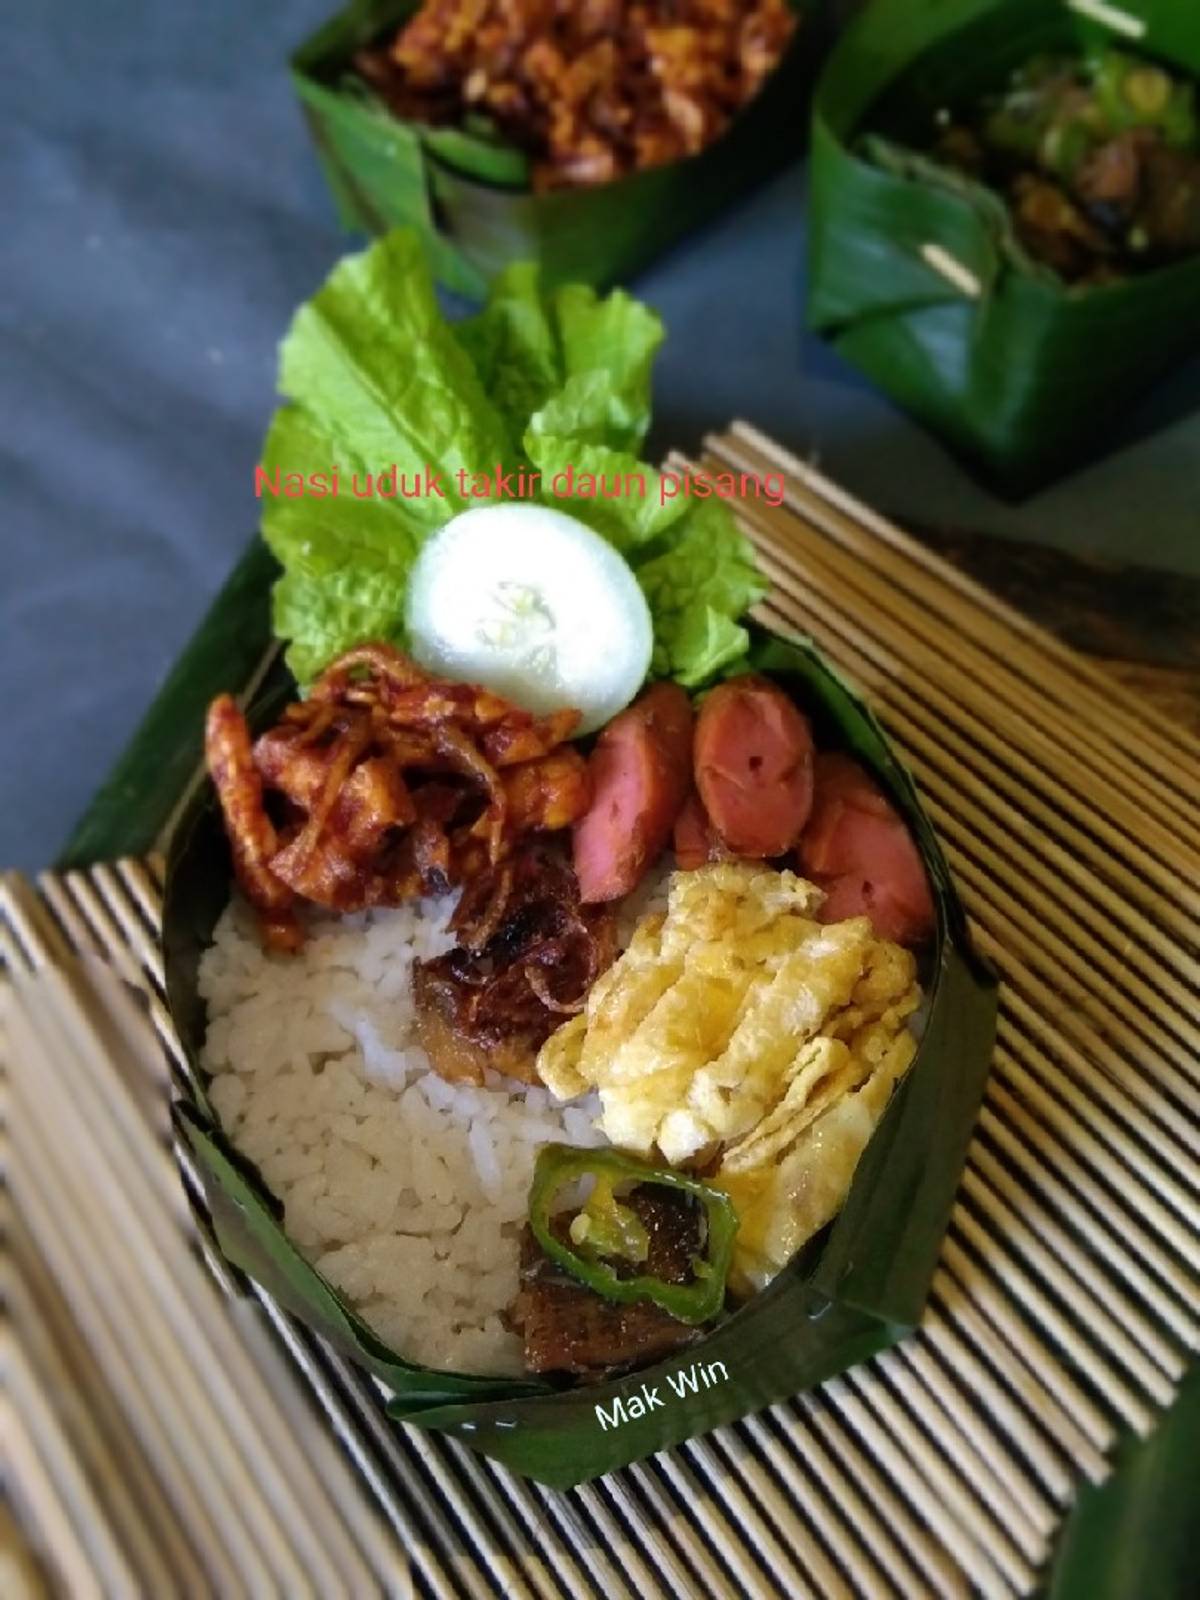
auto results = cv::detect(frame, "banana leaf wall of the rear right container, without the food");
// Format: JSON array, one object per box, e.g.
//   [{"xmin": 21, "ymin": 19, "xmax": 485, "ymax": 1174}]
[{"xmin": 808, "ymin": 0, "xmax": 1200, "ymax": 496}]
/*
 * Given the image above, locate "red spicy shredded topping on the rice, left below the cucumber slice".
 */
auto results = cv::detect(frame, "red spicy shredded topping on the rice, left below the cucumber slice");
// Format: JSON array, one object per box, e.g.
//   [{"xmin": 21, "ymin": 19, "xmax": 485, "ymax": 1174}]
[{"xmin": 205, "ymin": 643, "xmax": 590, "ymax": 950}]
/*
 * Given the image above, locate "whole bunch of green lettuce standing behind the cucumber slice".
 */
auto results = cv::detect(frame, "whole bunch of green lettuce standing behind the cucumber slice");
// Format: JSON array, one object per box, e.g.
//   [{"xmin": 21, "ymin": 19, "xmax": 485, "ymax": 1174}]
[{"xmin": 262, "ymin": 229, "xmax": 765, "ymax": 686}]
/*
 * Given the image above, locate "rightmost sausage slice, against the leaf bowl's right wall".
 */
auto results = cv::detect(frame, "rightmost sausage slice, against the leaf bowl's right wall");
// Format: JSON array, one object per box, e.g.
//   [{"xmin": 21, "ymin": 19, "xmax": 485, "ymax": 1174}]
[{"xmin": 797, "ymin": 750, "xmax": 936, "ymax": 944}]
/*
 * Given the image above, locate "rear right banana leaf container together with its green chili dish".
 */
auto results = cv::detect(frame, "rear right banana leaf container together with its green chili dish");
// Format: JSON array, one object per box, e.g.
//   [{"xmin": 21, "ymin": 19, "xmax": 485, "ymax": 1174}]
[{"xmin": 806, "ymin": 0, "xmax": 1200, "ymax": 498}]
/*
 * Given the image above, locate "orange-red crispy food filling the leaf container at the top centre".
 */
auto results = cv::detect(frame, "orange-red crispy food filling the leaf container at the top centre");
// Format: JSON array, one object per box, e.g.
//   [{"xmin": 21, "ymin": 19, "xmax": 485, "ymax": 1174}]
[{"xmin": 355, "ymin": 0, "xmax": 795, "ymax": 190}]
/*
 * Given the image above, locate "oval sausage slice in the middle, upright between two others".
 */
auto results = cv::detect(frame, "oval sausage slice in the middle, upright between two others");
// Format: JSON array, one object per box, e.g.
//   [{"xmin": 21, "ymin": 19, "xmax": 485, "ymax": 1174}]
[{"xmin": 696, "ymin": 675, "xmax": 813, "ymax": 859}]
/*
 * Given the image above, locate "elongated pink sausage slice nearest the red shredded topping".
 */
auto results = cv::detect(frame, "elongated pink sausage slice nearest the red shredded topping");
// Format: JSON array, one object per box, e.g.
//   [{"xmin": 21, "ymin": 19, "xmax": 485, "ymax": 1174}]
[{"xmin": 573, "ymin": 683, "xmax": 693, "ymax": 902}]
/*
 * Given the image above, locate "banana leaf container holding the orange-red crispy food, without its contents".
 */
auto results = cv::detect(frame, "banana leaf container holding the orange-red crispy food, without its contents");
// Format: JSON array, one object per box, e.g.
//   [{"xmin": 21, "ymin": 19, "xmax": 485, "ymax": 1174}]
[{"xmin": 291, "ymin": 0, "xmax": 827, "ymax": 299}]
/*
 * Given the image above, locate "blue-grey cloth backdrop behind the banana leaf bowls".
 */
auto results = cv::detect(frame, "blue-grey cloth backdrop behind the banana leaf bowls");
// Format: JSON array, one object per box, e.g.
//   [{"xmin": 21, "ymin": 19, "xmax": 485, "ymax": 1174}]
[{"xmin": 0, "ymin": 0, "xmax": 1200, "ymax": 869}]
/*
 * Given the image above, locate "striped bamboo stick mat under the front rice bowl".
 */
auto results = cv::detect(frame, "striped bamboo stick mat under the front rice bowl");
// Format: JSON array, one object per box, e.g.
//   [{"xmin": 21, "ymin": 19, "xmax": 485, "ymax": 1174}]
[{"xmin": 0, "ymin": 426, "xmax": 1200, "ymax": 1600}]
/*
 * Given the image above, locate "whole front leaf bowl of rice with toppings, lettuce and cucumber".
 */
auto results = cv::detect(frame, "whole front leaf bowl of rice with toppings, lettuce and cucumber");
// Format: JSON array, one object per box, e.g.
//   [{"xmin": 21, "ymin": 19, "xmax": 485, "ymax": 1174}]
[{"xmin": 163, "ymin": 234, "xmax": 995, "ymax": 1483}]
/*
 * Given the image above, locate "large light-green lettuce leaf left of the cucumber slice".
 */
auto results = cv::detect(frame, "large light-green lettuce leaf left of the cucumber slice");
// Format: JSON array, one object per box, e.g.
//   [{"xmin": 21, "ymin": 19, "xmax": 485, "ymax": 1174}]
[{"xmin": 262, "ymin": 230, "xmax": 518, "ymax": 683}]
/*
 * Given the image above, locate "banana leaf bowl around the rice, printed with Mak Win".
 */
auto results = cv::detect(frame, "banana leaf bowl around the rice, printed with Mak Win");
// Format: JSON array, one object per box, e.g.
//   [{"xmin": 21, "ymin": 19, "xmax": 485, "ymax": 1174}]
[{"xmin": 150, "ymin": 546, "xmax": 997, "ymax": 1486}]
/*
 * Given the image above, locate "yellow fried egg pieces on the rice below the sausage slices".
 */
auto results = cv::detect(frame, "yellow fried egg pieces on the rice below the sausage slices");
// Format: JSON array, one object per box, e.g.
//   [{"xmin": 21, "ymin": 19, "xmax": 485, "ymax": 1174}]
[{"xmin": 538, "ymin": 862, "xmax": 920, "ymax": 1291}]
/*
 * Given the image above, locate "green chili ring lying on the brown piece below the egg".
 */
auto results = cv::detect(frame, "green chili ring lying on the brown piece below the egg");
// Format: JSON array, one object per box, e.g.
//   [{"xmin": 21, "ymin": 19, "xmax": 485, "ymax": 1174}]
[{"xmin": 530, "ymin": 1144, "xmax": 738, "ymax": 1326}]
